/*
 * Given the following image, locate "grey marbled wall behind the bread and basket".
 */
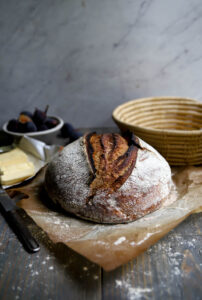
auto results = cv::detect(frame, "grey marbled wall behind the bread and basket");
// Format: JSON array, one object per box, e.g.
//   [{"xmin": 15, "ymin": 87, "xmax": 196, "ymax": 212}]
[{"xmin": 0, "ymin": 0, "xmax": 202, "ymax": 127}]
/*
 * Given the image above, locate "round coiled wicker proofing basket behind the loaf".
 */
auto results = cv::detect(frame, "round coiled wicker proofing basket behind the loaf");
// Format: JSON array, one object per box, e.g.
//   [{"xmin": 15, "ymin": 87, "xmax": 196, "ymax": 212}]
[{"xmin": 112, "ymin": 97, "xmax": 202, "ymax": 166}]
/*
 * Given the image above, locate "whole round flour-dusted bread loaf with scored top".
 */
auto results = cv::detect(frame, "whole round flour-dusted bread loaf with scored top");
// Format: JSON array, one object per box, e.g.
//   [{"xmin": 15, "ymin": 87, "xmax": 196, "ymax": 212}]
[{"xmin": 45, "ymin": 133, "xmax": 171, "ymax": 223}]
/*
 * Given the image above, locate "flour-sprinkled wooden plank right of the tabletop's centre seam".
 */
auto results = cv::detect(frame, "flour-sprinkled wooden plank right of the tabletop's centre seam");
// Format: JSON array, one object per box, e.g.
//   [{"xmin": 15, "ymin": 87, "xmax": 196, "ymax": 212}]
[{"xmin": 102, "ymin": 214, "xmax": 202, "ymax": 300}]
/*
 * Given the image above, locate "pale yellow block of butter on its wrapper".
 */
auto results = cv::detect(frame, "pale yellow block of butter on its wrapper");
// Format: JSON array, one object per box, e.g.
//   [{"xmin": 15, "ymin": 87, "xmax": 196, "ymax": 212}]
[{"xmin": 0, "ymin": 148, "xmax": 35, "ymax": 185}]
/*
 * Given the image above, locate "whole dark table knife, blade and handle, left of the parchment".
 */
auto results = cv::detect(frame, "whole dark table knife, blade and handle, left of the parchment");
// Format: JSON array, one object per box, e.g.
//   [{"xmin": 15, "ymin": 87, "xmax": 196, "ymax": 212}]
[{"xmin": 0, "ymin": 186, "xmax": 40, "ymax": 253}]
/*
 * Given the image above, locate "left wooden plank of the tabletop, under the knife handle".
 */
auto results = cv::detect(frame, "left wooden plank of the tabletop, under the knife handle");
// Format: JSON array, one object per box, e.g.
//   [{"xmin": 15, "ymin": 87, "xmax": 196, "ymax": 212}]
[{"xmin": 0, "ymin": 211, "xmax": 101, "ymax": 300}]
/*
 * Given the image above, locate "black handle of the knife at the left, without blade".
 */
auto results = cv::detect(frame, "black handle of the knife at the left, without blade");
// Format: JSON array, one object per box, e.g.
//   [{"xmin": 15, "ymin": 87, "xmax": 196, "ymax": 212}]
[{"xmin": 7, "ymin": 210, "xmax": 40, "ymax": 253}]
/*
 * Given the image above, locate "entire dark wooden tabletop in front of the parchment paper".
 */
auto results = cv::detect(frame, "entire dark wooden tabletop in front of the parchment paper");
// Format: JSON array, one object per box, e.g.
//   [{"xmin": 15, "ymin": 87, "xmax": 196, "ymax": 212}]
[{"xmin": 0, "ymin": 129, "xmax": 202, "ymax": 300}]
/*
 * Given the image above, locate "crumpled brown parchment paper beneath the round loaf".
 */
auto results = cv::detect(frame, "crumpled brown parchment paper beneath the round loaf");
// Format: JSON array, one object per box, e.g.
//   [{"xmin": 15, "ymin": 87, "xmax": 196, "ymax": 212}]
[{"xmin": 8, "ymin": 166, "xmax": 202, "ymax": 271}]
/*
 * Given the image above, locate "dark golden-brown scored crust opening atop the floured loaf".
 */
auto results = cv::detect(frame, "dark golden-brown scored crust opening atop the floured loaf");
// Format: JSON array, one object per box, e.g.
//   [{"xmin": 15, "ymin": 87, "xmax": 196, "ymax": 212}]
[{"xmin": 84, "ymin": 133, "xmax": 140, "ymax": 196}]
